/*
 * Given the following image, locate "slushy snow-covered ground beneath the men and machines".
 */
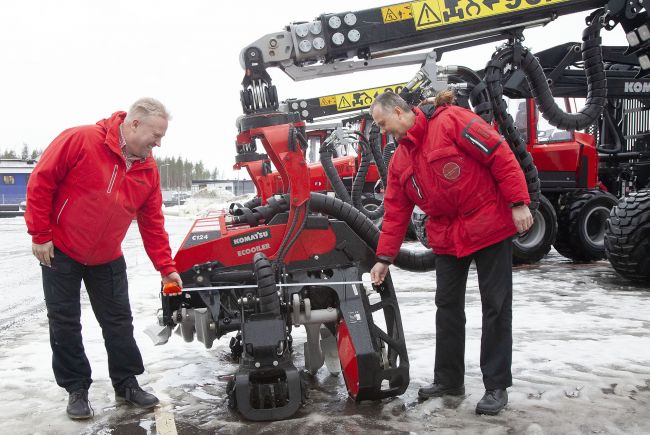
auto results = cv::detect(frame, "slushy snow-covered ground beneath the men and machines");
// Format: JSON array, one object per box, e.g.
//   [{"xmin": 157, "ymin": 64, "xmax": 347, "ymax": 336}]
[{"xmin": 0, "ymin": 209, "xmax": 650, "ymax": 434}]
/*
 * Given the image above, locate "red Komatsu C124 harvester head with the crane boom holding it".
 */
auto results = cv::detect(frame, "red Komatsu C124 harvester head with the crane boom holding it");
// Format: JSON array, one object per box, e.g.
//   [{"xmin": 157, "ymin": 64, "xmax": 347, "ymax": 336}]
[{"xmin": 151, "ymin": 0, "xmax": 650, "ymax": 420}]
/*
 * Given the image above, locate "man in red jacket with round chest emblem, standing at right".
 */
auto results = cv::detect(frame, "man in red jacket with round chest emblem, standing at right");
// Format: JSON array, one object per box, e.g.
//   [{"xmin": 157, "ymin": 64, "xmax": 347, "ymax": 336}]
[{"xmin": 370, "ymin": 91, "xmax": 533, "ymax": 415}]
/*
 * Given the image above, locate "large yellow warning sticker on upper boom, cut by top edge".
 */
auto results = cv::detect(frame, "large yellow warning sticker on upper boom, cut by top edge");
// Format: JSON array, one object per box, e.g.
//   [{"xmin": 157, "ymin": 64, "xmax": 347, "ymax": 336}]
[{"xmin": 412, "ymin": 0, "xmax": 569, "ymax": 30}]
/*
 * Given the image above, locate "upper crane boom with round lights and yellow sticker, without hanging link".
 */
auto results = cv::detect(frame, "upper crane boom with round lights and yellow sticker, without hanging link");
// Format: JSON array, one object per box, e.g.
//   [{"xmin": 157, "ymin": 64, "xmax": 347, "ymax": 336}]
[{"xmin": 240, "ymin": 0, "xmax": 607, "ymax": 75}]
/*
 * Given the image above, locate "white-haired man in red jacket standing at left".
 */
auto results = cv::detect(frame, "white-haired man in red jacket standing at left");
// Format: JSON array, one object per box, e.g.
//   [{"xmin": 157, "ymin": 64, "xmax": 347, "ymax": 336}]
[{"xmin": 25, "ymin": 98, "xmax": 182, "ymax": 419}]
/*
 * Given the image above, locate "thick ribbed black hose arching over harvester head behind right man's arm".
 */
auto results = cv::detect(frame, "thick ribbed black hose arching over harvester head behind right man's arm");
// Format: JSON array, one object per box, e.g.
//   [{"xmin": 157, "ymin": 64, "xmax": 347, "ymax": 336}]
[{"xmin": 234, "ymin": 192, "xmax": 435, "ymax": 272}]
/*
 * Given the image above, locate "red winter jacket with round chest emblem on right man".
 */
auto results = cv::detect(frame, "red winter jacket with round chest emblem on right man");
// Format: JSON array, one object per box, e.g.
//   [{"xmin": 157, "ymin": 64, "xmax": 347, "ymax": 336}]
[{"xmin": 377, "ymin": 106, "xmax": 530, "ymax": 262}]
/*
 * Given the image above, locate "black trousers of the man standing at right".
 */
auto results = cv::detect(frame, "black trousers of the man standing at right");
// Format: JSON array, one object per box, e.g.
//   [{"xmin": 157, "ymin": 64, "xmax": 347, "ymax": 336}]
[{"xmin": 434, "ymin": 238, "xmax": 512, "ymax": 390}]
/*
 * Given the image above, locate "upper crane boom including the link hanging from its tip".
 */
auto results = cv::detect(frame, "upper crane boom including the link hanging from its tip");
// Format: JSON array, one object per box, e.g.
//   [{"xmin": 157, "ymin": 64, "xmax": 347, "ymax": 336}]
[{"xmin": 240, "ymin": 0, "xmax": 650, "ymax": 113}]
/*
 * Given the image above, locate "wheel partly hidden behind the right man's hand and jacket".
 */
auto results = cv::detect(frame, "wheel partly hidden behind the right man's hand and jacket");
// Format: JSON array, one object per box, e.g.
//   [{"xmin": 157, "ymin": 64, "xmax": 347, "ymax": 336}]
[{"xmin": 512, "ymin": 195, "xmax": 557, "ymax": 264}]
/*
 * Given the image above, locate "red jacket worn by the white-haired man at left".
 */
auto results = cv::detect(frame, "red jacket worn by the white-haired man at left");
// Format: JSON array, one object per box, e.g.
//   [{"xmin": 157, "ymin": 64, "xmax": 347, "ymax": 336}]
[{"xmin": 25, "ymin": 112, "xmax": 176, "ymax": 276}]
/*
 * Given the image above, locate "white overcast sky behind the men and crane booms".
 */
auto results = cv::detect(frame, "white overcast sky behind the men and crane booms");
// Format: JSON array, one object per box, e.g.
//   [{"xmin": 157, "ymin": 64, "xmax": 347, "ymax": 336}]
[{"xmin": 0, "ymin": 0, "xmax": 626, "ymax": 175}]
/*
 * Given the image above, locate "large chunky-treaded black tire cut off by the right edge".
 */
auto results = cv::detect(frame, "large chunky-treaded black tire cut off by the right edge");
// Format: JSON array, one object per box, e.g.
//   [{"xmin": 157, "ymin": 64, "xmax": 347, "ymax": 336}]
[{"xmin": 605, "ymin": 189, "xmax": 650, "ymax": 284}]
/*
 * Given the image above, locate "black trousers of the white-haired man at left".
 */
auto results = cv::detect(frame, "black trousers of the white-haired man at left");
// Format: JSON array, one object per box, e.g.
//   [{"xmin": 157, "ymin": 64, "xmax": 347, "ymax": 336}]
[{"xmin": 42, "ymin": 249, "xmax": 144, "ymax": 392}]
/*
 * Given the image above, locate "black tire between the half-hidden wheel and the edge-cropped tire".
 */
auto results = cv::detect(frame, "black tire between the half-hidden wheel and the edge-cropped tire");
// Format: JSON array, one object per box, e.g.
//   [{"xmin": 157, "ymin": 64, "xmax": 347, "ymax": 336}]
[{"xmin": 553, "ymin": 189, "xmax": 618, "ymax": 261}]
